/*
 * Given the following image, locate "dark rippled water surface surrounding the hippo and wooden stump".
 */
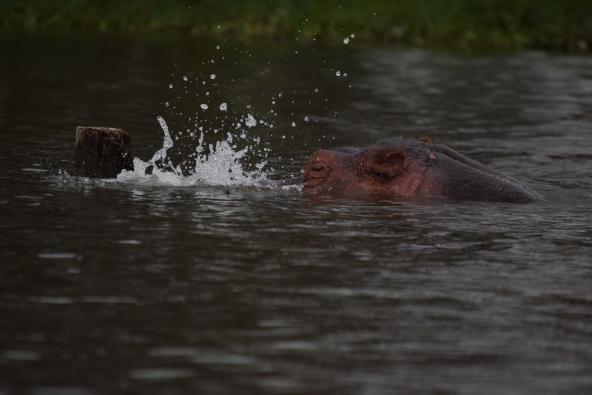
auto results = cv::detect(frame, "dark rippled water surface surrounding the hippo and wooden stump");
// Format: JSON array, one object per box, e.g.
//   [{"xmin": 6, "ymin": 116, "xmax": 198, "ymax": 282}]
[{"xmin": 0, "ymin": 37, "xmax": 592, "ymax": 395}]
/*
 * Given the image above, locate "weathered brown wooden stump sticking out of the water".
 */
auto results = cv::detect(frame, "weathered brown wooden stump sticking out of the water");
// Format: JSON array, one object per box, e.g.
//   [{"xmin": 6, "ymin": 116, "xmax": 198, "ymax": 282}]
[{"xmin": 74, "ymin": 126, "xmax": 134, "ymax": 178}]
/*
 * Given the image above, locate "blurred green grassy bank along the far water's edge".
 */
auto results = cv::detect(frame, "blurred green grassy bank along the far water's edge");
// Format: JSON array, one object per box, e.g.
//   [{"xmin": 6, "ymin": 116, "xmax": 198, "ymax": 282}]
[{"xmin": 0, "ymin": 0, "xmax": 592, "ymax": 51}]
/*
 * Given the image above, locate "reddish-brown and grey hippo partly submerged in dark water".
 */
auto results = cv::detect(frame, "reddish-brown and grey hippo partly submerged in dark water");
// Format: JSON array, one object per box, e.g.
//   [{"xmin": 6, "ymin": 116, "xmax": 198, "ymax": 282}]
[{"xmin": 302, "ymin": 137, "xmax": 538, "ymax": 203}]
